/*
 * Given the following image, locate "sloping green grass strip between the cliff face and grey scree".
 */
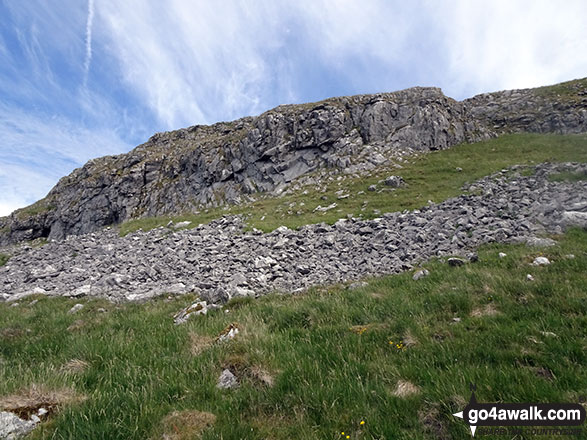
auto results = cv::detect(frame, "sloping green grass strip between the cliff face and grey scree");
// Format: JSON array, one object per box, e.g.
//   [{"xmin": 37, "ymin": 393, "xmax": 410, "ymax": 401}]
[{"xmin": 120, "ymin": 134, "xmax": 587, "ymax": 235}]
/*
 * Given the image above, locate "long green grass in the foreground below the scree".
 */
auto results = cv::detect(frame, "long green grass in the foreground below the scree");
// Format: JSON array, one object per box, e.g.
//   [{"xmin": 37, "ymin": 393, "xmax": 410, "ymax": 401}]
[{"xmin": 0, "ymin": 229, "xmax": 587, "ymax": 440}]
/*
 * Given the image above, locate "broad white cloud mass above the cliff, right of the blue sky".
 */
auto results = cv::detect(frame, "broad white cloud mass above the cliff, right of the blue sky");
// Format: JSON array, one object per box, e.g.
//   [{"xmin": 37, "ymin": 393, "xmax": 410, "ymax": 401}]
[{"xmin": 96, "ymin": 0, "xmax": 587, "ymax": 129}]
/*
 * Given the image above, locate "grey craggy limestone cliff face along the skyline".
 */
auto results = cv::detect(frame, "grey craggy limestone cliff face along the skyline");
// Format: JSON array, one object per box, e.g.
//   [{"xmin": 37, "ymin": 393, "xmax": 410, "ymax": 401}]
[{"xmin": 0, "ymin": 80, "xmax": 587, "ymax": 244}]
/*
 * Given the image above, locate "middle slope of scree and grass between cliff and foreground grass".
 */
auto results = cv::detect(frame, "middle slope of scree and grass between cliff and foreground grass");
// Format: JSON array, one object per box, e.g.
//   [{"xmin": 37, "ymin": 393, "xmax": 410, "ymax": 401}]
[{"xmin": 0, "ymin": 134, "xmax": 587, "ymax": 304}]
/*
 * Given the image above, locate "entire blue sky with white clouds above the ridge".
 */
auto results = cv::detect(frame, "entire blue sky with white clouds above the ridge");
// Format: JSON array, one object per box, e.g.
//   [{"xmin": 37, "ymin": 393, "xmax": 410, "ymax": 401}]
[{"xmin": 0, "ymin": 0, "xmax": 587, "ymax": 216}]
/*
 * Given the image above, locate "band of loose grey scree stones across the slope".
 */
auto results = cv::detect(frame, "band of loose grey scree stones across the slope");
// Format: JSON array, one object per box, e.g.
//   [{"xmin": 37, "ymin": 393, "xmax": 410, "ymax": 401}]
[{"xmin": 0, "ymin": 163, "xmax": 587, "ymax": 304}]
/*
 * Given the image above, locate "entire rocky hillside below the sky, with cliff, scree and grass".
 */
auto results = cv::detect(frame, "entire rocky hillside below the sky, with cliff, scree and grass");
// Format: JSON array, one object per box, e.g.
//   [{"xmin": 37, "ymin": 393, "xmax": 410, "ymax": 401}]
[{"xmin": 0, "ymin": 75, "xmax": 587, "ymax": 440}]
